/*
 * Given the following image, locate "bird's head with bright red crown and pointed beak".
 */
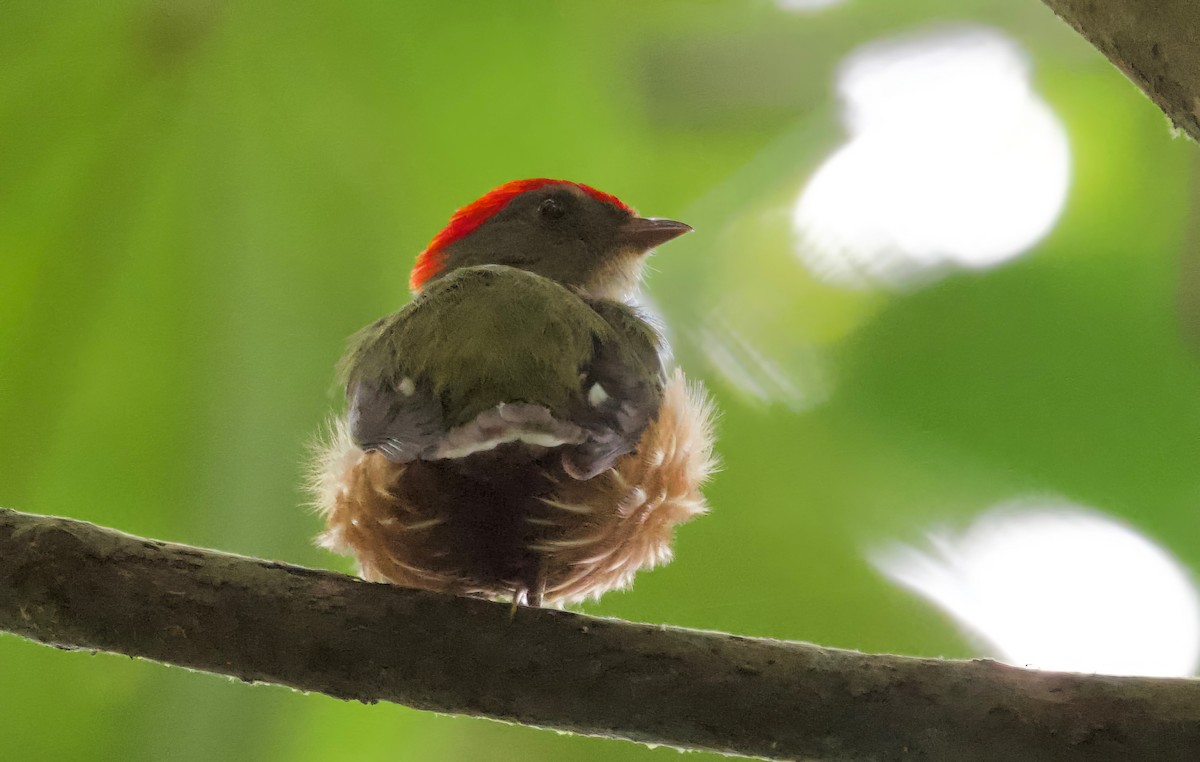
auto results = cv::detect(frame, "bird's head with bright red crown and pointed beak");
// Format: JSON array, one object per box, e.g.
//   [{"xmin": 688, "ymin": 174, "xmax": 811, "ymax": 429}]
[{"xmin": 409, "ymin": 178, "xmax": 691, "ymax": 299}]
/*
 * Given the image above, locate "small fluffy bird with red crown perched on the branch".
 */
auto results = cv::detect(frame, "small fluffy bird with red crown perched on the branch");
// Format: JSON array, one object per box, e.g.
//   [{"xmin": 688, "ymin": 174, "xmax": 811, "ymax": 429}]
[{"xmin": 312, "ymin": 179, "xmax": 714, "ymax": 606}]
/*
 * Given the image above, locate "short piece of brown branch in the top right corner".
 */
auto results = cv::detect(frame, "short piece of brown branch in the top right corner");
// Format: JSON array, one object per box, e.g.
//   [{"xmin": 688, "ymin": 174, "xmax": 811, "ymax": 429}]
[{"xmin": 1044, "ymin": 0, "xmax": 1200, "ymax": 140}]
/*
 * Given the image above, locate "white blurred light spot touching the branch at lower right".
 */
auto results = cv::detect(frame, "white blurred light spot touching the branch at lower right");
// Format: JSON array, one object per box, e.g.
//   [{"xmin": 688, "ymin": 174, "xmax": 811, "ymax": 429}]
[{"xmin": 872, "ymin": 502, "xmax": 1200, "ymax": 677}]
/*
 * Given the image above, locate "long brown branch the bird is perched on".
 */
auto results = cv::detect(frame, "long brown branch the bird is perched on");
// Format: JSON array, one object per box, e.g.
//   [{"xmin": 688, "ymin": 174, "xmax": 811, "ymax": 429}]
[{"xmin": 0, "ymin": 509, "xmax": 1200, "ymax": 762}]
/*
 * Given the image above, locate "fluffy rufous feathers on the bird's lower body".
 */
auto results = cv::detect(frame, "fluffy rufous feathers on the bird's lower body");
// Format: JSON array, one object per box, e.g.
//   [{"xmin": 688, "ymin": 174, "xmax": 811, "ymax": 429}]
[{"xmin": 312, "ymin": 371, "xmax": 714, "ymax": 604}]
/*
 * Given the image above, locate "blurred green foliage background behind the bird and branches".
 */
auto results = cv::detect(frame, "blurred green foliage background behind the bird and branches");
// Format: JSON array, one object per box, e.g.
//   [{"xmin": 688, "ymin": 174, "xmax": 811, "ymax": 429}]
[{"xmin": 0, "ymin": 0, "xmax": 1200, "ymax": 762}]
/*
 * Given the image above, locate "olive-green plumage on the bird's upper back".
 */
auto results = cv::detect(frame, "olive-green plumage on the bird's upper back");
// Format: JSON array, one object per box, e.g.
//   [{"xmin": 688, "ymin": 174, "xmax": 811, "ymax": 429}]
[{"xmin": 341, "ymin": 265, "xmax": 660, "ymax": 427}]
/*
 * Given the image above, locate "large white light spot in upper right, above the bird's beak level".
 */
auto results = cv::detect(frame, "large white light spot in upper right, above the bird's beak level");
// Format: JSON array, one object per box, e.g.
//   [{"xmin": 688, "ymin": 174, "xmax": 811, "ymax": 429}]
[{"xmin": 793, "ymin": 28, "xmax": 1070, "ymax": 287}]
